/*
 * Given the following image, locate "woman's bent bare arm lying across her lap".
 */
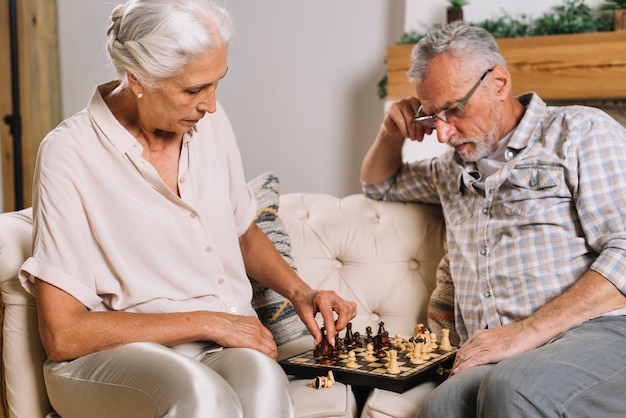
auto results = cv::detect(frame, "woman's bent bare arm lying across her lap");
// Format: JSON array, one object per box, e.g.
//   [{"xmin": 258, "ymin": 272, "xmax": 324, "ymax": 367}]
[{"xmin": 35, "ymin": 279, "xmax": 277, "ymax": 361}]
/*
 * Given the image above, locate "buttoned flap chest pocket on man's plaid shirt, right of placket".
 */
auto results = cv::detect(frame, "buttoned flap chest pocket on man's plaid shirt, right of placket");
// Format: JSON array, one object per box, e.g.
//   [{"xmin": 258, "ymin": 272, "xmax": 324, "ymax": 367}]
[{"xmin": 502, "ymin": 165, "xmax": 571, "ymax": 217}]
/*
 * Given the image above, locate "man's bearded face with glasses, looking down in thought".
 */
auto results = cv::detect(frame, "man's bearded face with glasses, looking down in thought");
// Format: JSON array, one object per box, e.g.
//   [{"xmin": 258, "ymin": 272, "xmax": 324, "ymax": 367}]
[{"xmin": 416, "ymin": 54, "xmax": 502, "ymax": 161}]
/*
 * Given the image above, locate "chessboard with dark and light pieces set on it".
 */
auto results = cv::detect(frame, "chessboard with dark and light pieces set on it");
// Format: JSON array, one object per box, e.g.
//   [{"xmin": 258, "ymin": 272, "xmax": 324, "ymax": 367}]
[{"xmin": 279, "ymin": 323, "xmax": 456, "ymax": 393}]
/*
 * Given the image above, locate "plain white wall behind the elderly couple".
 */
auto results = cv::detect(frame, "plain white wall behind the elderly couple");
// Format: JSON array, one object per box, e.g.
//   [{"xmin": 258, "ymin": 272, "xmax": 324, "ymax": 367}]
[{"xmin": 57, "ymin": 0, "xmax": 602, "ymax": 196}]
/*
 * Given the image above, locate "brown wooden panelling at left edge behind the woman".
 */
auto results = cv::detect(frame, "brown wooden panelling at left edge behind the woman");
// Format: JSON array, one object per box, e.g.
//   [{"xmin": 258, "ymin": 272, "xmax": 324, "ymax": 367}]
[{"xmin": 0, "ymin": 0, "xmax": 61, "ymax": 211}]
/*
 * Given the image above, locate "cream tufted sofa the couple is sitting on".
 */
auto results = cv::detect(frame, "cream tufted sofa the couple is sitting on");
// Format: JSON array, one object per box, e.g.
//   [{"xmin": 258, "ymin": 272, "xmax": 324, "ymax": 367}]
[{"xmin": 0, "ymin": 193, "xmax": 445, "ymax": 418}]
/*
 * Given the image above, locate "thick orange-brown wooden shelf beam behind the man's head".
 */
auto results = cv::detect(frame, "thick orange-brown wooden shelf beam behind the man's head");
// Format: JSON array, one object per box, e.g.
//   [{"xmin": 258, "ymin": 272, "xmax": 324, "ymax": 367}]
[{"xmin": 387, "ymin": 31, "xmax": 626, "ymax": 100}]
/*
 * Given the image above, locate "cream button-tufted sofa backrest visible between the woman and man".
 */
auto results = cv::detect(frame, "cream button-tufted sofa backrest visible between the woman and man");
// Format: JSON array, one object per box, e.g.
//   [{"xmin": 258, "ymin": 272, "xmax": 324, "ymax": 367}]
[{"xmin": 279, "ymin": 193, "xmax": 445, "ymax": 336}]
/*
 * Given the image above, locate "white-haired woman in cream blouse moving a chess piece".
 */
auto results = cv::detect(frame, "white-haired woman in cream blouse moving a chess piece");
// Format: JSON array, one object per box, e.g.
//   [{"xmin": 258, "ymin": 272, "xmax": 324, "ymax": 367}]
[{"xmin": 20, "ymin": 0, "xmax": 356, "ymax": 418}]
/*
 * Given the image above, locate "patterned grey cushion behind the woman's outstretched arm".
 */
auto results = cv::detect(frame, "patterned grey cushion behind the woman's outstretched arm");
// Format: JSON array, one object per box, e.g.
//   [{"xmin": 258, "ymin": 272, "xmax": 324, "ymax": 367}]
[{"xmin": 248, "ymin": 172, "xmax": 309, "ymax": 345}]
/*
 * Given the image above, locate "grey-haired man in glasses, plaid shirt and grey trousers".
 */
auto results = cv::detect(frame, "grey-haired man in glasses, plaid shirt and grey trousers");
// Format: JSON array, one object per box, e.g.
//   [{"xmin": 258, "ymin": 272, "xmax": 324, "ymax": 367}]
[{"xmin": 361, "ymin": 23, "xmax": 626, "ymax": 418}]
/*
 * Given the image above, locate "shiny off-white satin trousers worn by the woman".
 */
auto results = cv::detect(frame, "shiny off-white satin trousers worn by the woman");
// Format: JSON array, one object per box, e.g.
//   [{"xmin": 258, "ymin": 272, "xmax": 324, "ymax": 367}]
[{"xmin": 44, "ymin": 343, "xmax": 294, "ymax": 418}]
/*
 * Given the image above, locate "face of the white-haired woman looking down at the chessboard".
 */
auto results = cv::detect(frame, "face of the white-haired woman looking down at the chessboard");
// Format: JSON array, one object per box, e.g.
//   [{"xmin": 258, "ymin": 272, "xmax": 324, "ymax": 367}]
[{"xmin": 137, "ymin": 44, "xmax": 228, "ymax": 134}]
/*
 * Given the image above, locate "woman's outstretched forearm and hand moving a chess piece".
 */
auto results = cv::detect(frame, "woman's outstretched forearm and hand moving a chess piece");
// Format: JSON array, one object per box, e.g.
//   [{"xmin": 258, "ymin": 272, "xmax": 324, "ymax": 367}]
[{"xmin": 239, "ymin": 222, "xmax": 356, "ymax": 345}]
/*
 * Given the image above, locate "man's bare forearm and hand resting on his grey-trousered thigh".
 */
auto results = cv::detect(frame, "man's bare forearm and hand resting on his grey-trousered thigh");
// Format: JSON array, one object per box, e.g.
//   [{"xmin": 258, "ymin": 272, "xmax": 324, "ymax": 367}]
[{"xmin": 452, "ymin": 270, "xmax": 626, "ymax": 374}]
